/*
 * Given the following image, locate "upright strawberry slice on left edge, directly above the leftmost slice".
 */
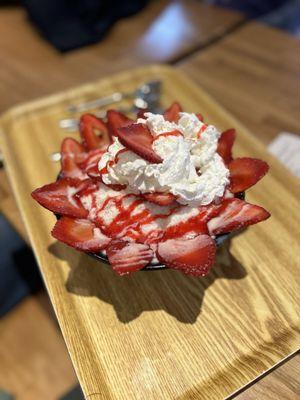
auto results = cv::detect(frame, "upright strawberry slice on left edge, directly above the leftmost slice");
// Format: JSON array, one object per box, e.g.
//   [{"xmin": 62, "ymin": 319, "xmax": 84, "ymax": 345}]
[{"xmin": 61, "ymin": 138, "xmax": 87, "ymax": 179}]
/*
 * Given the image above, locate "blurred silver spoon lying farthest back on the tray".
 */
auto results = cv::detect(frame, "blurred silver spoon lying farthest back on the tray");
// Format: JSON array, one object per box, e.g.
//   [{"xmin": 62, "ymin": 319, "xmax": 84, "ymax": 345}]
[{"xmin": 67, "ymin": 80, "xmax": 161, "ymax": 112}]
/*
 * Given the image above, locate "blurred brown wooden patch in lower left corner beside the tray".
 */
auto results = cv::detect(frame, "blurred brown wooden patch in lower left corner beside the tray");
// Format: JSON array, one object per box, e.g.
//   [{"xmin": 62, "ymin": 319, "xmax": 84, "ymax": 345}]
[{"xmin": 0, "ymin": 296, "xmax": 77, "ymax": 400}]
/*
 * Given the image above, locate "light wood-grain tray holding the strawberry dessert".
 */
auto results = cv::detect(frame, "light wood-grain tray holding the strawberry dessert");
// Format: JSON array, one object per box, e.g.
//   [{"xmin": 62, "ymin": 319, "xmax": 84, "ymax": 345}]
[{"xmin": 1, "ymin": 66, "xmax": 300, "ymax": 400}]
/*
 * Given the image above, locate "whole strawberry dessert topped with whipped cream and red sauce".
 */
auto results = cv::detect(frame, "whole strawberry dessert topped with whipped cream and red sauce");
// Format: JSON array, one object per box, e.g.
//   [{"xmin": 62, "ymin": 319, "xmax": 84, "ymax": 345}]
[{"xmin": 32, "ymin": 103, "xmax": 270, "ymax": 276}]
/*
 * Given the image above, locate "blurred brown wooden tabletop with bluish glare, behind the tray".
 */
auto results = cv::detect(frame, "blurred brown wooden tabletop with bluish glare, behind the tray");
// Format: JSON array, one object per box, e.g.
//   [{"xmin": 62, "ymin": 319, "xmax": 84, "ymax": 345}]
[{"xmin": 0, "ymin": 0, "xmax": 244, "ymax": 112}]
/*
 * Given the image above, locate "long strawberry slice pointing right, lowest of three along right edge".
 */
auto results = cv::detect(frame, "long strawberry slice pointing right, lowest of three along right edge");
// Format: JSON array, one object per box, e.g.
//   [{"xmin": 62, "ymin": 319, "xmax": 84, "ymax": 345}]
[{"xmin": 207, "ymin": 198, "xmax": 270, "ymax": 235}]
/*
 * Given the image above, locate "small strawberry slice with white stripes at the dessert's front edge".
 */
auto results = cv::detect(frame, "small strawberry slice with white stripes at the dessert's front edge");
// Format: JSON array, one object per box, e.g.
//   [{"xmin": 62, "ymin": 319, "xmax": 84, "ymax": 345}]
[{"xmin": 106, "ymin": 240, "xmax": 153, "ymax": 275}]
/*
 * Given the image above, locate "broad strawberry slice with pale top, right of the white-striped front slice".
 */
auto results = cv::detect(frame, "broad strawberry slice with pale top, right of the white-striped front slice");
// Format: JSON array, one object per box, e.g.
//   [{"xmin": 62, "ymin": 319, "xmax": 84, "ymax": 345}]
[{"xmin": 156, "ymin": 235, "xmax": 216, "ymax": 276}]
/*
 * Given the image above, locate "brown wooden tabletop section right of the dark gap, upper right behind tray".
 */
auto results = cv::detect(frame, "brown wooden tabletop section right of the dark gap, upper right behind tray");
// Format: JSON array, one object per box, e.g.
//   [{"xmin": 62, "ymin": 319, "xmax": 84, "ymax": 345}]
[{"xmin": 180, "ymin": 22, "xmax": 300, "ymax": 144}]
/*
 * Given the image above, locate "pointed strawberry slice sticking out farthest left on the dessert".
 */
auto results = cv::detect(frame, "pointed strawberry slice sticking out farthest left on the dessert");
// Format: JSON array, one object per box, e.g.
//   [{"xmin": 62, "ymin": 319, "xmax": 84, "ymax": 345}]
[{"xmin": 31, "ymin": 178, "xmax": 90, "ymax": 218}]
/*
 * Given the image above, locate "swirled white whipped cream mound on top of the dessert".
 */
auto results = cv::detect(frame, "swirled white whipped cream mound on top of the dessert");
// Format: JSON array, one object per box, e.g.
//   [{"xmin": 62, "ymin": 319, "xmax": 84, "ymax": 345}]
[{"xmin": 98, "ymin": 112, "xmax": 229, "ymax": 206}]
